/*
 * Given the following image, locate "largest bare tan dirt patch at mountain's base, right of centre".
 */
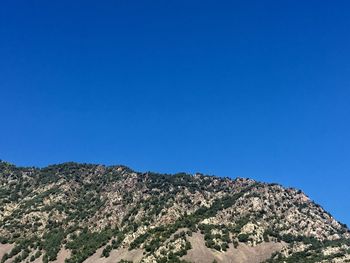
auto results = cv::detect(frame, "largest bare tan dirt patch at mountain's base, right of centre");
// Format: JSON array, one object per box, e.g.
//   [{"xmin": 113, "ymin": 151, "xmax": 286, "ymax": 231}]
[{"xmin": 183, "ymin": 233, "xmax": 284, "ymax": 263}]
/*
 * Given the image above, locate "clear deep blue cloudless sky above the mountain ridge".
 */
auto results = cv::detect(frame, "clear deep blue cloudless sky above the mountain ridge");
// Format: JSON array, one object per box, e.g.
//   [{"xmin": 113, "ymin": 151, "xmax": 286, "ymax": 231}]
[{"xmin": 0, "ymin": 0, "xmax": 350, "ymax": 224}]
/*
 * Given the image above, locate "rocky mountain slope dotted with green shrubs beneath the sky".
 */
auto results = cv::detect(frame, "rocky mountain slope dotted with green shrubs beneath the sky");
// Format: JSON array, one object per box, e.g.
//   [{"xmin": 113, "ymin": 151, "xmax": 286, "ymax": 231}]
[{"xmin": 0, "ymin": 162, "xmax": 350, "ymax": 263}]
